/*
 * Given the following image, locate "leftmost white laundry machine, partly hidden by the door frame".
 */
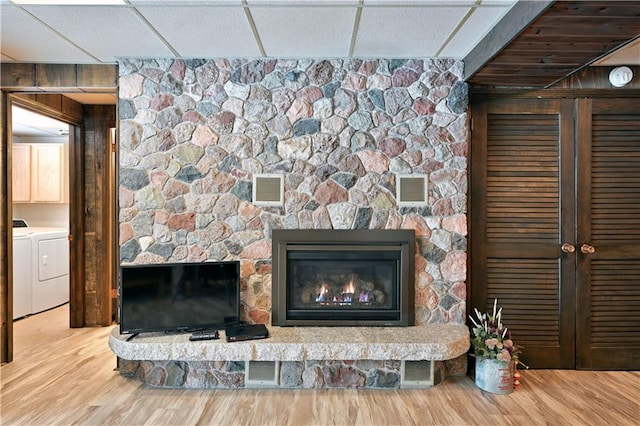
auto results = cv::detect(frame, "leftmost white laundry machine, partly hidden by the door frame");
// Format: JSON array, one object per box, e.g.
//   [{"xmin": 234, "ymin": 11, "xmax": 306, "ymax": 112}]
[{"xmin": 13, "ymin": 229, "xmax": 33, "ymax": 319}]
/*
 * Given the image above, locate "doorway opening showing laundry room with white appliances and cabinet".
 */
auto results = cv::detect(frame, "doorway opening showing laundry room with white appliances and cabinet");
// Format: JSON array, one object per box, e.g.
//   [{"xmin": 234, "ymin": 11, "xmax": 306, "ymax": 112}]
[{"xmin": 10, "ymin": 104, "xmax": 70, "ymax": 321}]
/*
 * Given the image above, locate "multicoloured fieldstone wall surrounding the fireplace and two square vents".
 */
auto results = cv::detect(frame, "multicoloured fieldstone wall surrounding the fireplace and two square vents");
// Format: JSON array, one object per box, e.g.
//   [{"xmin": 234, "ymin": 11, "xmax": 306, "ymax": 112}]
[{"xmin": 118, "ymin": 59, "xmax": 468, "ymax": 324}]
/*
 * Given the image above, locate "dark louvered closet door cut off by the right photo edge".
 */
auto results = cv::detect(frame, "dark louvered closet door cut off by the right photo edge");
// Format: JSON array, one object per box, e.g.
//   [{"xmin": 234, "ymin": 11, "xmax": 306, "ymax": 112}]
[{"xmin": 577, "ymin": 99, "xmax": 640, "ymax": 369}]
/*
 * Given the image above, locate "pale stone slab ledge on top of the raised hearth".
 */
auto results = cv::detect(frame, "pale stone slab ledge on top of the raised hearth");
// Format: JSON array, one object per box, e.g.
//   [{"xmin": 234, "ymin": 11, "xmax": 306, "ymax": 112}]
[{"xmin": 109, "ymin": 324, "xmax": 470, "ymax": 361}]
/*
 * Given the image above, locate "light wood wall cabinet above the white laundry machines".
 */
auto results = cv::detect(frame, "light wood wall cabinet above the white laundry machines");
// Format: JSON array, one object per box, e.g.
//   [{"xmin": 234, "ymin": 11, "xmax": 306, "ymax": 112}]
[{"xmin": 11, "ymin": 143, "xmax": 65, "ymax": 203}]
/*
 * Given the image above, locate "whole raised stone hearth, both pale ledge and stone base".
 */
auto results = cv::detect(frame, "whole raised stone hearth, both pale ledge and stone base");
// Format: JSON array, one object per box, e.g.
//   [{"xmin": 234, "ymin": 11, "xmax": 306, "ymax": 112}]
[{"xmin": 109, "ymin": 324, "xmax": 469, "ymax": 388}]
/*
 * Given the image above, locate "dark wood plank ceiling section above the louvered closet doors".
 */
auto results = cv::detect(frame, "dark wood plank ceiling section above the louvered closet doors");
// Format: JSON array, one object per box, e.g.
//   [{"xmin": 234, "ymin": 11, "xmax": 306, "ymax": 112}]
[{"xmin": 465, "ymin": 1, "xmax": 640, "ymax": 88}]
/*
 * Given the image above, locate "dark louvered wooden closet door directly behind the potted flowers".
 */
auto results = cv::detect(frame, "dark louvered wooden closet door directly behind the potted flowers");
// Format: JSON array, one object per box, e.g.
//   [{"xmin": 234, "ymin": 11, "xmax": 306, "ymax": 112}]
[{"xmin": 469, "ymin": 99, "xmax": 576, "ymax": 368}]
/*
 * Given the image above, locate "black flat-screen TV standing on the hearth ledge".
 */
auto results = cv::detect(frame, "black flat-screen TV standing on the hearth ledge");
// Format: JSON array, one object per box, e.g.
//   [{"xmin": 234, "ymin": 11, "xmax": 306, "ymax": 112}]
[{"xmin": 120, "ymin": 261, "xmax": 240, "ymax": 334}]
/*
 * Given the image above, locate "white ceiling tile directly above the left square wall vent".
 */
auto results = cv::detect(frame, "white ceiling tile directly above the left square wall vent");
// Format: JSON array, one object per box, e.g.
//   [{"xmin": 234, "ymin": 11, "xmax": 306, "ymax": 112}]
[{"xmin": 246, "ymin": 6, "xmax": 357, "ymax": 58}]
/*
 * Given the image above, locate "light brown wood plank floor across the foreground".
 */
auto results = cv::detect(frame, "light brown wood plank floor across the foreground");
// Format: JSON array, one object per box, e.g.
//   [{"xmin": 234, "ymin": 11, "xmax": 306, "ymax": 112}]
[{"xmin": 0, "ymin": 306, "xmax": 640, "ymax": 425}]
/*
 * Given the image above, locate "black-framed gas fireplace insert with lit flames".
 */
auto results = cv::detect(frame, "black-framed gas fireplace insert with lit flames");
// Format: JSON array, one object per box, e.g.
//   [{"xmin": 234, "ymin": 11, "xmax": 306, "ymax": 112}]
[{"xmin": 272, "ymin": 230, "xmax": 415, "ymax": 326}]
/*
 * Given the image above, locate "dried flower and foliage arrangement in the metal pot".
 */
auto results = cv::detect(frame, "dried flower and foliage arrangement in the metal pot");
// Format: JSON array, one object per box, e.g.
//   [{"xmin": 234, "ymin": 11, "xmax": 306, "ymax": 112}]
[{"xmin": 469, "ymin": 299, "xmax": 522, "ymax": 362}]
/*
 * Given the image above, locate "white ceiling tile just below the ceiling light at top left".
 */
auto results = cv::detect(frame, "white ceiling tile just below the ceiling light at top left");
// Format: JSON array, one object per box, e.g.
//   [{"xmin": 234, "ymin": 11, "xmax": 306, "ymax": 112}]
[{"xmin": 20, "ymin": 6, "xmax": 173, "ymax": 62}]
